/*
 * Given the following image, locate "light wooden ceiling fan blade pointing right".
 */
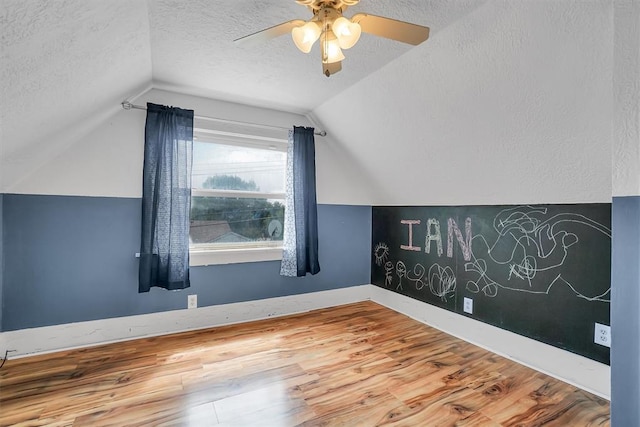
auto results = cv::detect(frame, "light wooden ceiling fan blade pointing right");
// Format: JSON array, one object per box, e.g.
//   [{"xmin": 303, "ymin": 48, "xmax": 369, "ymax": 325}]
[{"xmin": 351, "ymin": 13, "xmax": 429, "ymax": 46}]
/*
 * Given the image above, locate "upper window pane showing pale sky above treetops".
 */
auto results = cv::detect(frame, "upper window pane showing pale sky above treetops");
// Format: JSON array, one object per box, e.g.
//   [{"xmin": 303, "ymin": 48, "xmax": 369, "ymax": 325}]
[{"xmin": 192, "ymin": 141, "xmax": 287, "ymax": 193}]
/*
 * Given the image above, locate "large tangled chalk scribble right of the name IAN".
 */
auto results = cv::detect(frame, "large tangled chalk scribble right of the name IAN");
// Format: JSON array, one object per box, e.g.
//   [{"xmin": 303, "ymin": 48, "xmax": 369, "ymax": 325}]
[{"xmin": 464, "ymin": 206, "xmax": 611, "ymax": 302}]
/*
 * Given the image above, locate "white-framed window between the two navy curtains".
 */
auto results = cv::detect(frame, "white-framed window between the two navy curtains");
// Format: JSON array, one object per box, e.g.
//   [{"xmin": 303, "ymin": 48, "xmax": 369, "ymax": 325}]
[{"xmin": 189, "ymin": 129, "xmax": 287, "ymax": 265}]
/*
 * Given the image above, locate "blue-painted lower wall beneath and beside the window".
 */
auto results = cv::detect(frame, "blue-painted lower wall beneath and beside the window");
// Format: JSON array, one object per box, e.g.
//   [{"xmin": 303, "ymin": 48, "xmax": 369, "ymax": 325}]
[{"xmin": 2, "ymin": 194, "xmax": 371, "ymax": 331}]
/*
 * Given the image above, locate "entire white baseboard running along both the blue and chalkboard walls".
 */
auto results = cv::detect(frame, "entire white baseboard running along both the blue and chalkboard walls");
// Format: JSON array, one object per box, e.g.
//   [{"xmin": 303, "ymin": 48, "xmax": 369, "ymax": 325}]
[{"xmin": 0, "ymin": 285, "xmax": 611, "ymax": 399}]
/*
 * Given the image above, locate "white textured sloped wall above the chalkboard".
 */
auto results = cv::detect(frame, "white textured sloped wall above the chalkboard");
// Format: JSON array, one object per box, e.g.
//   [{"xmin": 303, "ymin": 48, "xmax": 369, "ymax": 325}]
[{"xmin": 314, "ymin": 1, "xmax": 612, "ymax": 205}]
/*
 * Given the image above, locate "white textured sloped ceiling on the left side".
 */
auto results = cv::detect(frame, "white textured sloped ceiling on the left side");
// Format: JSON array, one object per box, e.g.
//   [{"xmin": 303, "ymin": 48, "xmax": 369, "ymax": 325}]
[{"xmin": 0, "ymin": 0, "xmax": 151, "ymax": 191}]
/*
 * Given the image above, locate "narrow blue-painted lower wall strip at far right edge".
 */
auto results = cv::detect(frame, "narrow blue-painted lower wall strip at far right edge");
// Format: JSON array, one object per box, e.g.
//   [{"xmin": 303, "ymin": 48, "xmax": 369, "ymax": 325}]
[{"xmin": 611, "ymin": 196, "xmax": 640, "ymax": 426}]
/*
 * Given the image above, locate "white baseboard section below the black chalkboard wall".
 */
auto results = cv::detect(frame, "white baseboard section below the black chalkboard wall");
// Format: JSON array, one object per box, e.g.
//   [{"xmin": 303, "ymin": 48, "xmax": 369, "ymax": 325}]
[{"xmin": 369, "ymin": 286, "xmax": 611, "ymax": 400}]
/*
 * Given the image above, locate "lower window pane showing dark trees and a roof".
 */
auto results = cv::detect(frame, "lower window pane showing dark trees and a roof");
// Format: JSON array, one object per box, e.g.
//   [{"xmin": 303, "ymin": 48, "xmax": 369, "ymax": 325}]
[{"xmin": 190, "ymin": 197, "xmax": 284, "ymax": 246}]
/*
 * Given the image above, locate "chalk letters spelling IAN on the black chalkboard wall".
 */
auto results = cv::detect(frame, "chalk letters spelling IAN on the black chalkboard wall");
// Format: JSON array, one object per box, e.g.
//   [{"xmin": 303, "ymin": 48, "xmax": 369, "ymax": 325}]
[{"xmin": 400, "ymin": 218, "xmax": 473, "ymax": 261}]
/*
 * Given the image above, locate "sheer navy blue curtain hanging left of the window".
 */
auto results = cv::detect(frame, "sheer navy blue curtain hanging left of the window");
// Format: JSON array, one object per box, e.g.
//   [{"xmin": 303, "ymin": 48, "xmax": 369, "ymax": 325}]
[{"xmin": 138, "ymin": 103, "xmax": 193, "ymax": 292}]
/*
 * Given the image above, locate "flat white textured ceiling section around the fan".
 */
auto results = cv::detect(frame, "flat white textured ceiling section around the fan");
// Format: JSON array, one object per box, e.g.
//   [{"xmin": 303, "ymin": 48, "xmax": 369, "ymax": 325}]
[{"xmin": 149, "ymin": 0, "xmax": 431, "ymax": 112}]
